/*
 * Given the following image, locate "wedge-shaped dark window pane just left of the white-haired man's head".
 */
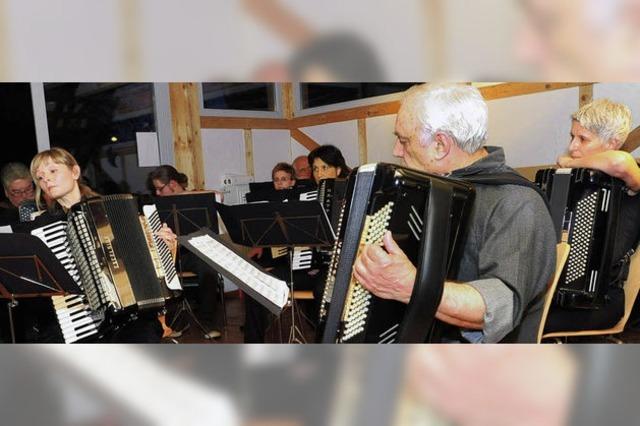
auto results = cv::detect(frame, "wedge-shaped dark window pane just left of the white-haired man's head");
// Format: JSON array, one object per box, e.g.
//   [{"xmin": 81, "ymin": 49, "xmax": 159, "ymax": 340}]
[{"xmin": 300, "ymin": 83, "xmax": 416, "ymax": 109}]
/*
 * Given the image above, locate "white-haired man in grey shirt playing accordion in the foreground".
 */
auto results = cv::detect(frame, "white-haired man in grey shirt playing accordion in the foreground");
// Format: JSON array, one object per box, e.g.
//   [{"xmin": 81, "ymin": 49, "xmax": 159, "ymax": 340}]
[{"xmin": 354, "ymin": 84, "xmax": 556, "ymax": 343}]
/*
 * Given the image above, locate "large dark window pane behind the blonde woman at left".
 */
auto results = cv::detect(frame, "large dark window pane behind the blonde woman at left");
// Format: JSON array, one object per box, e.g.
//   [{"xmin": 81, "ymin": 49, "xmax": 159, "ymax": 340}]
[{"xmin": 44, "ymin": 83, "xmax": 156, "ymax": 194}]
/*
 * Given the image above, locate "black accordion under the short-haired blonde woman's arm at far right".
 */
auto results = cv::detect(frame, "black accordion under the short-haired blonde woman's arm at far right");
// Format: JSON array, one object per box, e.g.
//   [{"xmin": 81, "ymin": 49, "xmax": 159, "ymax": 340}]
[{"xmin": 536, "ymin": 169, "xmax": 624, "ymax": 309}]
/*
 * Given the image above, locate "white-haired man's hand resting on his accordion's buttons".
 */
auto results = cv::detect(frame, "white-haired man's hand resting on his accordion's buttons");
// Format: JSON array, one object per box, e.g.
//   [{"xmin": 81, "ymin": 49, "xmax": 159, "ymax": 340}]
[{"xmin": 353, "ymin": 231, "xmax": 416, "ymax": 303}]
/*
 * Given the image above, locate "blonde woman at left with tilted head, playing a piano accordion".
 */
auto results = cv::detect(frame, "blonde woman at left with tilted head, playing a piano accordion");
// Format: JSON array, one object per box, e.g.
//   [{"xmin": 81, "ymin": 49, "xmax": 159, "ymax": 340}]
[{"xmin": 25, "ymin": 148, "xmax": 177, "ymax": 343}]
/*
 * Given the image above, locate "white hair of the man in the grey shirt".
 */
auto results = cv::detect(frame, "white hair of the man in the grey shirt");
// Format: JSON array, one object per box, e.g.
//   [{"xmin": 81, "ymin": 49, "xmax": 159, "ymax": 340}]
[{"xmin": 400, "ymin": 84, "xmax": 488, "ymax": 154}]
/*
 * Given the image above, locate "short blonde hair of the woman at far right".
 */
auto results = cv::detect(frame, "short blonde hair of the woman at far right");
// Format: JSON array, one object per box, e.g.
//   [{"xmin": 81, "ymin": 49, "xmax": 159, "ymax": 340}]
[{"xmin": 571, "ymin": 99, "xmax": 631, "ymax": 144}]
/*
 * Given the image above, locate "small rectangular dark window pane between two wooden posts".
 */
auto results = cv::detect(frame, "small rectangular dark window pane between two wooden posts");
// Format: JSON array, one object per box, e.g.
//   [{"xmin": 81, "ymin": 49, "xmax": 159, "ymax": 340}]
[{"xmin": 202, "ymin": 83, "xmax": 276, "ymax": 111}]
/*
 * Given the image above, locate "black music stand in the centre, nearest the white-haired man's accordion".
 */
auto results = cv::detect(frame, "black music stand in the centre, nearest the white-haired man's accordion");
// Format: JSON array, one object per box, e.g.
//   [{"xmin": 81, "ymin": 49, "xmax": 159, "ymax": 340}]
[{"xmin": 216, "ymin": 201, "xmax": 335, "ymax": 343}]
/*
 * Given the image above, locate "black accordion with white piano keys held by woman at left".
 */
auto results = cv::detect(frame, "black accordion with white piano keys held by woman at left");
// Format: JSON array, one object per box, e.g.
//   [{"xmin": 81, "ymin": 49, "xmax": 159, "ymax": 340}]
[{"xmin": 32, "ymin": 195, "xmax": 181, "ymax": 343}]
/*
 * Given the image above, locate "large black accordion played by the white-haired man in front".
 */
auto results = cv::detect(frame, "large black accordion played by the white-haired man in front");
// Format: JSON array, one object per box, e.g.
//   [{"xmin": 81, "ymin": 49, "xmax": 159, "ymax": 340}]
[{"xmin": 318, "ymin": 163, "xmax": 474, "ymax": 343}]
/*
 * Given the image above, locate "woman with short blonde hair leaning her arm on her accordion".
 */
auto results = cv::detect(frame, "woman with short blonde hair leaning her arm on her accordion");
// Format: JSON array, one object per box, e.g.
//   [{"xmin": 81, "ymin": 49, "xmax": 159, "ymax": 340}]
[{"xmin": 545, "ymin": 99, "xmax": 640, "ymax": 332}]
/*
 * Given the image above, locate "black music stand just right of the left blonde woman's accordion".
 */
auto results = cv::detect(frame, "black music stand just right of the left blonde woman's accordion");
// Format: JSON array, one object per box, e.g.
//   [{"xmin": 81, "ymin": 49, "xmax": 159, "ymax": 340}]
[{"xmin": 153, "ymin": 191, "xmax": 224, "ymax": 336}]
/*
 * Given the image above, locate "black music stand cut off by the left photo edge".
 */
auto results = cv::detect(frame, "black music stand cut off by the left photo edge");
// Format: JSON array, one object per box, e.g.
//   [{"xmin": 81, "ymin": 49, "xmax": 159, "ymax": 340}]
[{"xmin": 0, "ymin": 234, "xmax": 81, "ymax": 343}]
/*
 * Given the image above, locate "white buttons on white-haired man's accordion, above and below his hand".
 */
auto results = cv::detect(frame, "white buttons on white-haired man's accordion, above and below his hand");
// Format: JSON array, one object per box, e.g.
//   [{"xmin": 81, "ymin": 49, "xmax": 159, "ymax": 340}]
[{"xmin": 340, "ymin": 202, "xmax": 393, "ymax": 342}]
